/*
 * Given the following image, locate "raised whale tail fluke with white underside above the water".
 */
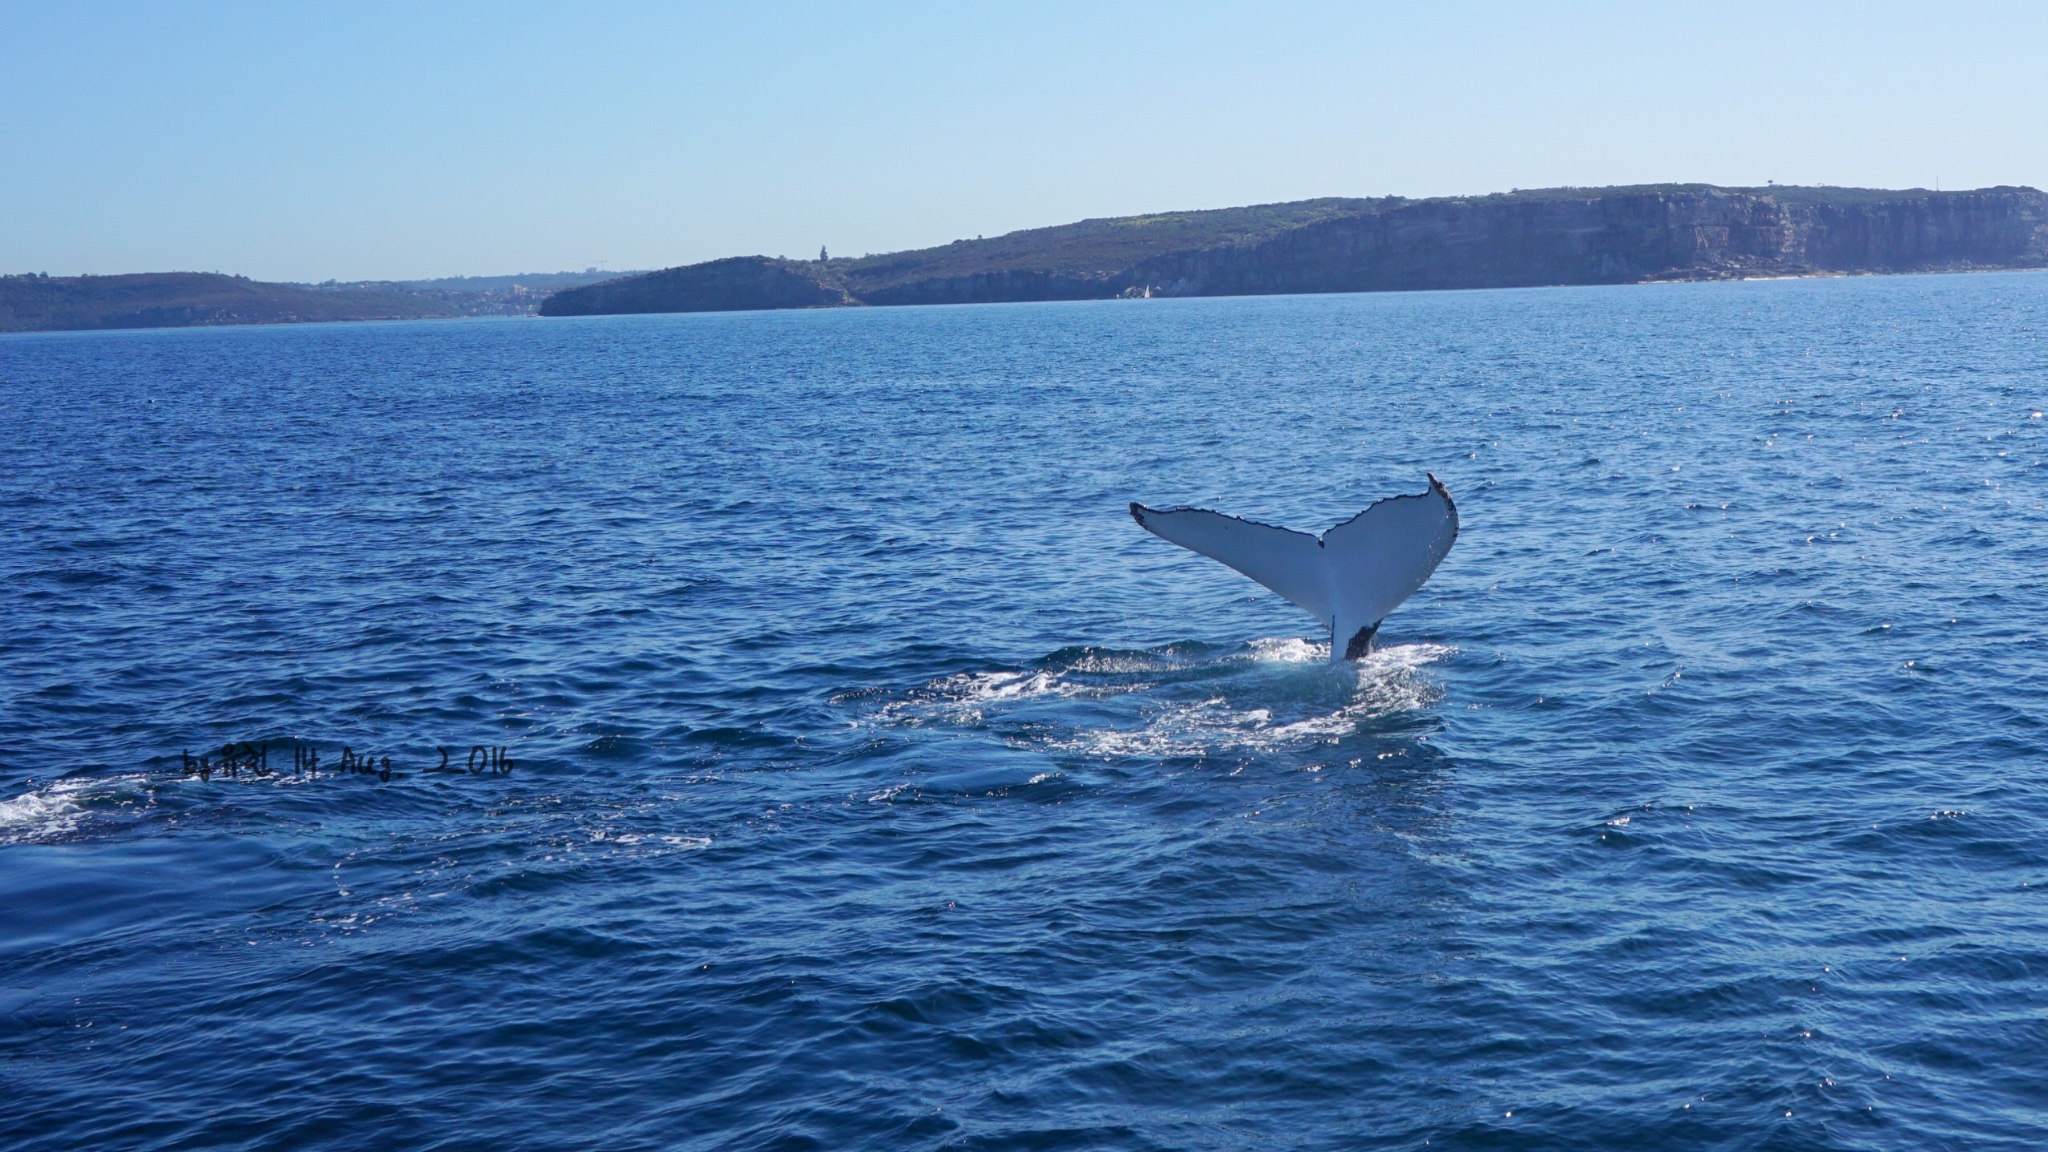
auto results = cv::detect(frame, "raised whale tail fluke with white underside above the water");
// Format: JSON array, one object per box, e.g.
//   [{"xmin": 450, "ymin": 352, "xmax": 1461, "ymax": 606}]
[{"xmin": 1130, "ymin": 476, "xmax": 1458, "ymax": 664}]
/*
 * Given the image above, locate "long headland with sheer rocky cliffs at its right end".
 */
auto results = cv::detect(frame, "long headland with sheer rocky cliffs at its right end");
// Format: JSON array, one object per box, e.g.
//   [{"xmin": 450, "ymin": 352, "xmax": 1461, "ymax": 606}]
[{"xmin": 541, "ymin": 184, "xmax": 2048, "ymax": 316}]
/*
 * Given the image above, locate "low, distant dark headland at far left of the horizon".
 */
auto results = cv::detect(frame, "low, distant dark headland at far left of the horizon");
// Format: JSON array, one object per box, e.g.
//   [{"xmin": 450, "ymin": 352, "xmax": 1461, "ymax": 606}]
[{"xmin": 0, "ymin": 269, "xmax": 618, "ymax": 332}]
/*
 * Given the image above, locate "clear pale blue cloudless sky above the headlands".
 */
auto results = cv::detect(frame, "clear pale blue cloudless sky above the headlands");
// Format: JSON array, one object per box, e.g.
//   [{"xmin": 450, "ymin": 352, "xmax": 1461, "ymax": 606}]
[{"xmin": 0, "ymin": 0, "xmax": 2048, "ymax": 279}]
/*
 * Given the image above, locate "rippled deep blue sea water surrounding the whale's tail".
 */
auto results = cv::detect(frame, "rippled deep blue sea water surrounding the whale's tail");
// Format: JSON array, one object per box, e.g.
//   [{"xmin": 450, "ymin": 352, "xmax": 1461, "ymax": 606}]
[{"xmin": 0, "ymin": 275, "xmax": 2048, "ymax": 1150}]
